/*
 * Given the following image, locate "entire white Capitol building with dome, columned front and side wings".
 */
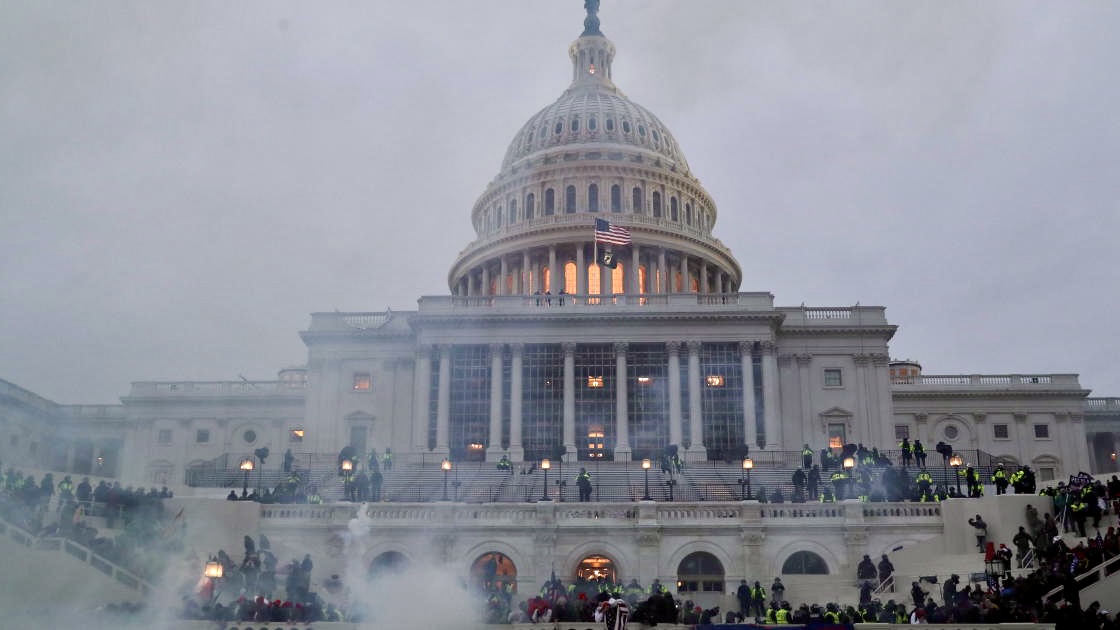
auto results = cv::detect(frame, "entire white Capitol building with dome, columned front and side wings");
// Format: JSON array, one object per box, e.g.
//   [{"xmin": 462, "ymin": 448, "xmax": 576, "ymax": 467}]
[{"xmin": 0, "ymin": 0, "xmax": 1120, "ymax": 596}]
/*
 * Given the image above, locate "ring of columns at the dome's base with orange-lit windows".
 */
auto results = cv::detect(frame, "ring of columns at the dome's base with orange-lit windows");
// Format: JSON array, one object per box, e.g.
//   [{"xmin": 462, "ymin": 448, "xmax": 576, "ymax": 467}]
[{"xmin": 456, "ymin": 243, "xmax": 735, "ymax": 296}]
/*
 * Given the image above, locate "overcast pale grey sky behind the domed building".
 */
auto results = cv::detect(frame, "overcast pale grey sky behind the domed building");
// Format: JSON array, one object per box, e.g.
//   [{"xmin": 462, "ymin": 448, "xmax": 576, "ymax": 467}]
[{"xmin": 0, "ymin": 0, "xmax": 1120, "ymax": 402}]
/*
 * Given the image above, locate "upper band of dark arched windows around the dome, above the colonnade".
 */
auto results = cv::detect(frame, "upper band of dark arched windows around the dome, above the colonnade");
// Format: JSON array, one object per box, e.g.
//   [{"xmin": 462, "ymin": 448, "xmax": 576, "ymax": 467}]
[{"xmin": 479, "ymin": 184, "xmax": 711, "ymax": 233}]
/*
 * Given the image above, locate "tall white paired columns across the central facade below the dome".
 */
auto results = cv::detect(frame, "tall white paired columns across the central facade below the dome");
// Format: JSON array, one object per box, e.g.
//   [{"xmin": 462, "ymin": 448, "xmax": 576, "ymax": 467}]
[{"xmin": 413, "ymin": 341, "xmax": 782, "ymax": 461}]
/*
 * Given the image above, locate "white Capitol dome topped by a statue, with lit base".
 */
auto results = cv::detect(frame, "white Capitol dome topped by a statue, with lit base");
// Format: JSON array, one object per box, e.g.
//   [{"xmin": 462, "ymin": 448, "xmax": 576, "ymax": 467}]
[{"xmin": 448, "ymin": 2, "xmax": 743, "ymax": 296}]
